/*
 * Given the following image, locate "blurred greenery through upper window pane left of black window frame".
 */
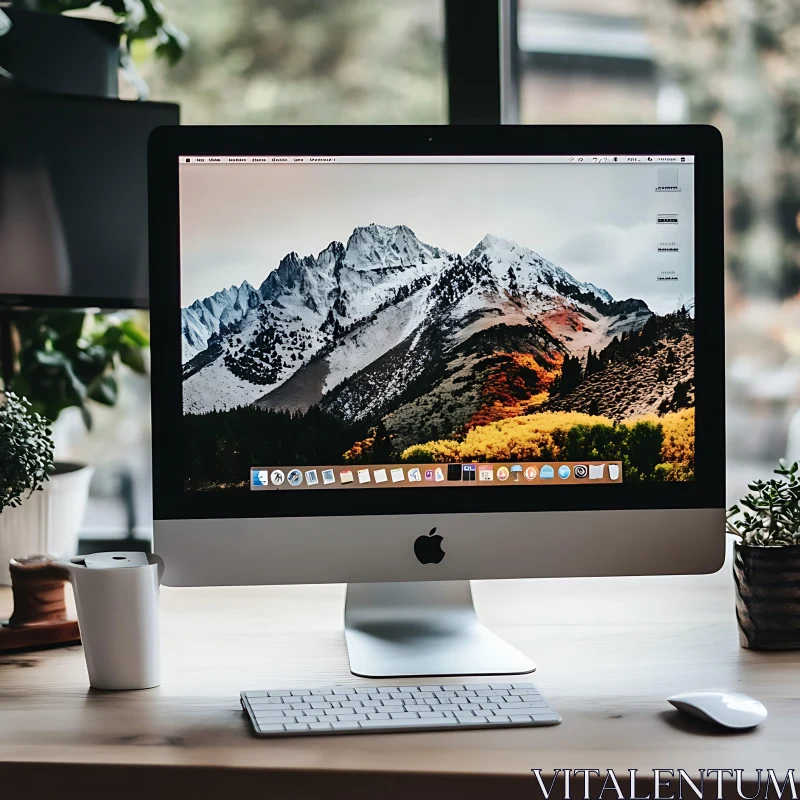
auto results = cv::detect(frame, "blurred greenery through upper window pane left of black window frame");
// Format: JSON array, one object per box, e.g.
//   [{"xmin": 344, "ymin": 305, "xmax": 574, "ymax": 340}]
[{"xmin": 128, "ymin": 0, "xmax": 447, "ymax": 124}]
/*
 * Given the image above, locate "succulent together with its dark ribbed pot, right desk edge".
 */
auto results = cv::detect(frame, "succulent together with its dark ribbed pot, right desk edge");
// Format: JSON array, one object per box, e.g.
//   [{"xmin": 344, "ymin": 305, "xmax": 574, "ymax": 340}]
[{"xmin": 727, "ymin": 462, "xmax": 800, "ymax": 650}]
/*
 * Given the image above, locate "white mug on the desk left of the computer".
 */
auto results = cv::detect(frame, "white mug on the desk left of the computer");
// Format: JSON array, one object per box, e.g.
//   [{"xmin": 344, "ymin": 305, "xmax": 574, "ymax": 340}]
[{"xmin": 59, "ymin": 553, "xmax": 164, "ymax": 689}]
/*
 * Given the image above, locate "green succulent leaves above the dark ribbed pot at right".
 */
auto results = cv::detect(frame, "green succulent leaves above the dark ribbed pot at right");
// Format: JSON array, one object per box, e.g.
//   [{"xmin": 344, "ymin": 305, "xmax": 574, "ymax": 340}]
[{"xmin": 727, "ymin": 461, "xmax": 800, "ymax": 547}]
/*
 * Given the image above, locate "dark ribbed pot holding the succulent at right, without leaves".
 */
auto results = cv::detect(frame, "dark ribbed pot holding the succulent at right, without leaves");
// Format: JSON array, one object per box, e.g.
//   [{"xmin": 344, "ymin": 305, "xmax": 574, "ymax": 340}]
[{"xmin": 733, "ymin": 542, "xmax": 800, "ymax": 650}]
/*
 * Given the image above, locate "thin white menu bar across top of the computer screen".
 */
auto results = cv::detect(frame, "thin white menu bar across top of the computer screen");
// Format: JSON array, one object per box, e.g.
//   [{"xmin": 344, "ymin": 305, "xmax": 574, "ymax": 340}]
[{"xmin": 178, "ymin": 154, "xmax": 694, "ymax": 165}]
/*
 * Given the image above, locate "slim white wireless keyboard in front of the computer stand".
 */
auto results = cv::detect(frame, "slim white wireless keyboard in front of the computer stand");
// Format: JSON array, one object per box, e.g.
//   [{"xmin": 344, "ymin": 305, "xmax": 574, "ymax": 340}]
[{"xmin": 241, "ymin": 683, "xmax": 561, "ymax": 737}]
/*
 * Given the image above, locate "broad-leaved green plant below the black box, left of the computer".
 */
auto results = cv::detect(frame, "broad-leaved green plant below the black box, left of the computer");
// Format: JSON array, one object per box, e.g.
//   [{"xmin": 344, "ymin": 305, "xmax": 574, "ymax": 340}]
[{"xmin": 9, "ymin": 311, "xmax": 148, "ymax": 429}]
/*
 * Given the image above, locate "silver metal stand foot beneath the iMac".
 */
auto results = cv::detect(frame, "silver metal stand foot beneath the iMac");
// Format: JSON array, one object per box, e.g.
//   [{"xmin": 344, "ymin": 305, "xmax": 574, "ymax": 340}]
[{"xmin": 344, "ymin": 581, "xmax": 536, "ymax": 678}]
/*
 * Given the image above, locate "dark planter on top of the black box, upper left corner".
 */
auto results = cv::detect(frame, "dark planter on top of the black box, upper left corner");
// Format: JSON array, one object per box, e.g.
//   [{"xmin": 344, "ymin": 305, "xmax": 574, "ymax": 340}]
[{"xmin": 0, "ymin": 8, "xmax": 119, "ymax": 97}]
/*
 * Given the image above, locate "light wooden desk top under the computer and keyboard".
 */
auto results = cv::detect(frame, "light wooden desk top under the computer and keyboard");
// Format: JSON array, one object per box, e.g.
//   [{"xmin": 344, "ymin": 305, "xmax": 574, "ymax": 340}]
[{"xmin": 0, "ymin": 536, "xmax": 800, "ymax": 800}]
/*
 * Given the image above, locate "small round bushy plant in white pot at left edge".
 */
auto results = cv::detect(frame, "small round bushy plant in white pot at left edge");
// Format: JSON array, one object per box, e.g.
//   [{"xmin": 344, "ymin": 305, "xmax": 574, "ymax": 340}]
[{"xmin": 0, "ymin": 392, "xmax": 55, "ymax": 584}]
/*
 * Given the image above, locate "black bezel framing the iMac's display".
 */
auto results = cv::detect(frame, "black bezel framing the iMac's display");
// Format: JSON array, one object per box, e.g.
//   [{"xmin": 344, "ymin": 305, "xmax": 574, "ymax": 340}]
[{"xmin": 148, "ymin": 125, "xmax": 725, "ymax": 520}]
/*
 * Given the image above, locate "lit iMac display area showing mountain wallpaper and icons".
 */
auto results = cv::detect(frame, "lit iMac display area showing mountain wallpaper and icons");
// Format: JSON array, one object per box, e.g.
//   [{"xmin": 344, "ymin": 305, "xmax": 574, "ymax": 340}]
[{"xmin": 176, "ymin": 153, "xmax": 695, "ymax": 494}]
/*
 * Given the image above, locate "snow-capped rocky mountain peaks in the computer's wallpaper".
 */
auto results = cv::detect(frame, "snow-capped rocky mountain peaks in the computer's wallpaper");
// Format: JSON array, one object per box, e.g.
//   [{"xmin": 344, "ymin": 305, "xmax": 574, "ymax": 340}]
[{"xmin": 182, "ymin": 224, "xmax": 650, "ymax": 419}]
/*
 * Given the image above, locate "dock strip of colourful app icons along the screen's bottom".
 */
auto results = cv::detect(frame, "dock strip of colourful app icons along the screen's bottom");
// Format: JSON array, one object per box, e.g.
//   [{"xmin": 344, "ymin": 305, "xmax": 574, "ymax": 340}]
[{"xmin": 250, "ymin": 461, "xmax": 622, "ymax": 491}]
